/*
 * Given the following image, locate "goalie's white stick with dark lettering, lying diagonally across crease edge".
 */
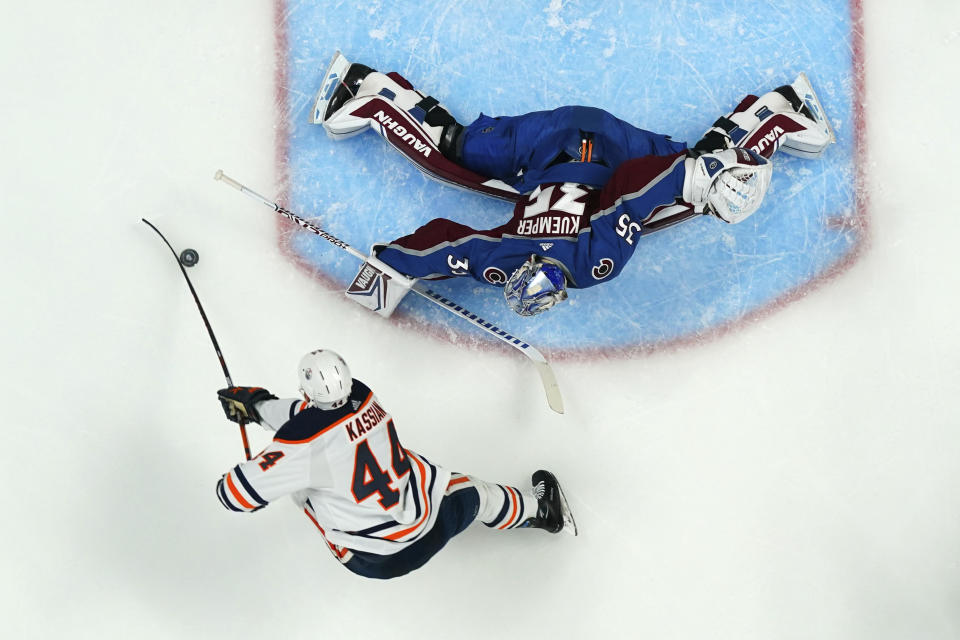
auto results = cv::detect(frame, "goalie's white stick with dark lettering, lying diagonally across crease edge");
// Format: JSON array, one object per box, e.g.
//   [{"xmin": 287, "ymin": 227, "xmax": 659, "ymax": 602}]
[{"xmin": 212, "ymin": 169, "xmax": 563, "ymax": 413}]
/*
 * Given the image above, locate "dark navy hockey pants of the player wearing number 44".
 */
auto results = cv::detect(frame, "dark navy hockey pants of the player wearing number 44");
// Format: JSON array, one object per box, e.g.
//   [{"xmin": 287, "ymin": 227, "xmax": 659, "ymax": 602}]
[{"xmin": 344, "ymin": 487, "xmax": 480, "ymax": 580}]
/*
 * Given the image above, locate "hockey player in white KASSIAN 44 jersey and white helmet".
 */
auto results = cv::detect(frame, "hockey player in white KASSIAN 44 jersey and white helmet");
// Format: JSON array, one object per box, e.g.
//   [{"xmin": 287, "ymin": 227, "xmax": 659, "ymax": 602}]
[{"xmin": 217, "ymin": 349, "xmax": 576, "ymax": 579}]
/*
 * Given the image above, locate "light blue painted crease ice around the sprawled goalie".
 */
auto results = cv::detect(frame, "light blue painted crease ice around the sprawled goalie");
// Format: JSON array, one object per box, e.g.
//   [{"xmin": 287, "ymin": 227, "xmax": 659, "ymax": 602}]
[{"xmin": 276, "ymin": 0, "xmax": 869, "ymax": 357}]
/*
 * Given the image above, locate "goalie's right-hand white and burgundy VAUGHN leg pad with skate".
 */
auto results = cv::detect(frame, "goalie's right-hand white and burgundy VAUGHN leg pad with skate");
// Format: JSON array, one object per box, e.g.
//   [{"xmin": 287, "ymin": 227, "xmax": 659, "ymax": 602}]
[{"xmin": 692, "ymin": 73, "xmax": 836, "ymax": 158}]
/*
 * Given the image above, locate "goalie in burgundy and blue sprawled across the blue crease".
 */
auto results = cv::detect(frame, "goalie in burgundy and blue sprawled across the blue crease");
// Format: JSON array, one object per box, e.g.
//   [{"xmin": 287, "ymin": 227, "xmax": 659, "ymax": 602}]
[{"xmin": 312, "ymin": 52, "xmax": 834, "ymax": 315}]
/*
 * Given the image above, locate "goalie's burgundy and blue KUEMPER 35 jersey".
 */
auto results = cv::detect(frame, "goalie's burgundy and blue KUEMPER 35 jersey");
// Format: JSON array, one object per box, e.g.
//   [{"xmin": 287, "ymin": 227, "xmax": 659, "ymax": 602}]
[{"xmin": 378, "ymin": 153, "xmax": 695, "ymax": 288}]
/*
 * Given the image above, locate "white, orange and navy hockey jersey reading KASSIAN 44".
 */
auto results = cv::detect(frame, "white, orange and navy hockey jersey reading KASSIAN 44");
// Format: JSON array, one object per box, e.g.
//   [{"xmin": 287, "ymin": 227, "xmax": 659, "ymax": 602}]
[{"xmin": 217, "ymin": 380, "xmax": 450, "ymax": 562}]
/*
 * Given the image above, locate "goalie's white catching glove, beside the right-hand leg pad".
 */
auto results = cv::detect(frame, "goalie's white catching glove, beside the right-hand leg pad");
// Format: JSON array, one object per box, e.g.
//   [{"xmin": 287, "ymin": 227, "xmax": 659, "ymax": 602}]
[{"xmin": 683, "ymin": 147, "xmax": 773, "ymax": 224}]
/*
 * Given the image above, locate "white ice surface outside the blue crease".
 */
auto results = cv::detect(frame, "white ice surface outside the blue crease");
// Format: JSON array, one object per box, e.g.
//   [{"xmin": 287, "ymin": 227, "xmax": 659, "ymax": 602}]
[{"xmin": 0, "ymin": 0, "xmax": 960, "ymax": 640}]
